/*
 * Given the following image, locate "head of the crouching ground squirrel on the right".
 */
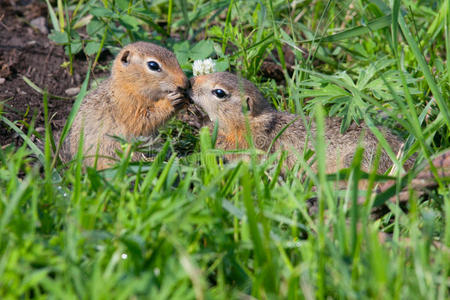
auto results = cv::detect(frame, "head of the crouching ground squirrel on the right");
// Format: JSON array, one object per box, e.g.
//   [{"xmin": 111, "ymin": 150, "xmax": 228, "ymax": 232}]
[{"xmin": 189, "ymin": 72, "xmax": 271, "ymax": 123}]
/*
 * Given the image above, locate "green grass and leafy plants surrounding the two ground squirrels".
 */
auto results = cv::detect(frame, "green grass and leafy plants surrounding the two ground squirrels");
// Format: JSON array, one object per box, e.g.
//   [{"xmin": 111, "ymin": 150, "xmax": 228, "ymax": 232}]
[{"xmin": 0, "ymin": 0, "xmax": 450, "ymax": 299}]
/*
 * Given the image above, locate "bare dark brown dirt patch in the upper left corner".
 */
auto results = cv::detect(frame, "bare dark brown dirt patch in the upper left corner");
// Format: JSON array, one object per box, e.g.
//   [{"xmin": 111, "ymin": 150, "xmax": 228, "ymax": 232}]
[{"xmin": 0, "ymin": 0, "xmax": 103, "ymax": 145}]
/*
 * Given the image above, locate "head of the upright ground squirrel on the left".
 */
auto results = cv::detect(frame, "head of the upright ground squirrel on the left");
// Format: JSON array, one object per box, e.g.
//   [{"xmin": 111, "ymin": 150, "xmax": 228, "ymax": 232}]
[{"xmin": 112, "ymin": 42, "xmax": 189, "ymax": 101}]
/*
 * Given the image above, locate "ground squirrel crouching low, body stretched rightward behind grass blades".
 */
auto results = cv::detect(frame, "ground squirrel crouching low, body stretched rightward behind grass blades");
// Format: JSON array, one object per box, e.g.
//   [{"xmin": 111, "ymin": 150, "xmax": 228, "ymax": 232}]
[{"xmin": 190, "ymin": 72, "xmax": 411, "ymax": 172}]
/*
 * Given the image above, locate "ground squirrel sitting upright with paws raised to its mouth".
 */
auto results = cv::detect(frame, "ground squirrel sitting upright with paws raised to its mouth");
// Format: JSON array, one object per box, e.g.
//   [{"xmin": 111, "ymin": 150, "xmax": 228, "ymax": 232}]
[{"xmin": 62, "ymin": 42, "xmax": 189, "ymax": 169}]
